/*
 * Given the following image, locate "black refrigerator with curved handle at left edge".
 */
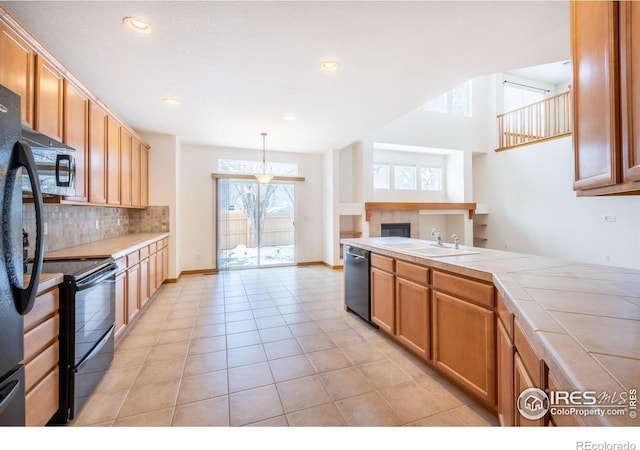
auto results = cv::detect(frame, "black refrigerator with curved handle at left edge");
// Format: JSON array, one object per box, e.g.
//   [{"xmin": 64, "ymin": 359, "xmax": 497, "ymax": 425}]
[{"xmin": 0, "ymin": 85, "xmax": 44, "ymax": 426}]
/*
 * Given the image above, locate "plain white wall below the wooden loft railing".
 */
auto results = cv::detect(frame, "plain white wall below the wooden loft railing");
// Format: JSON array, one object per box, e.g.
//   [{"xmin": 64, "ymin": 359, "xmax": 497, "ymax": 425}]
[{"xmin": 474, "ymin": 137, "xmax": 640, "ymax": 269}]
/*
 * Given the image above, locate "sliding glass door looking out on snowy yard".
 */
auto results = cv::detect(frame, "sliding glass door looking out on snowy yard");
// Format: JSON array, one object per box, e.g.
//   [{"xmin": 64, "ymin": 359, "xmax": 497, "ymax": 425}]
[{"xmin": 217, "ymin": 178, "xmax": 295, "ymax": 270}]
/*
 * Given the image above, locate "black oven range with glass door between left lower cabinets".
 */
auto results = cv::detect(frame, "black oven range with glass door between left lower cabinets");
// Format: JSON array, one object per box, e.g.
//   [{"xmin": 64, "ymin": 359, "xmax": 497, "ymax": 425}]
[{"xmin": 38, "ymin": 256, "xmax": 117, "ymax": 425}]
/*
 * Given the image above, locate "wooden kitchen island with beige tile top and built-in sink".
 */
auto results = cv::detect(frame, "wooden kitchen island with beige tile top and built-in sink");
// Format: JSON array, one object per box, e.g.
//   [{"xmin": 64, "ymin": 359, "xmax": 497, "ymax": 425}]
[{"xmin": 341, "ymin": 237, "xmax": 640, "ymax": 426}]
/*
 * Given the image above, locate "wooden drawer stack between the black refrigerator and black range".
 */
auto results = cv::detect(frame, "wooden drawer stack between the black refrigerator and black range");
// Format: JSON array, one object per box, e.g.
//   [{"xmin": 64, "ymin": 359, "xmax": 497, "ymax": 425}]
[{"xmin": 22, "ymin": 286, "xmax": 60, "ymax": 426}]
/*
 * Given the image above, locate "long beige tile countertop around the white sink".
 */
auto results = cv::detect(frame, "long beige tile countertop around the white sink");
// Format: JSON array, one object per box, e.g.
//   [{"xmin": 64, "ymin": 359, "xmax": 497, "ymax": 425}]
[{"xmin": 341, "ymin": 238, "xmax": 640, "ymax": 426}]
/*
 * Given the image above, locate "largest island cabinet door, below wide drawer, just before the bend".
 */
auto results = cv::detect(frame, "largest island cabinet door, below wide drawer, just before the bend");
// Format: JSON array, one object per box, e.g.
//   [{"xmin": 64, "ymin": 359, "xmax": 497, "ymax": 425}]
[{"xmin": 433, "ymin": 291, "xmax": 496, "ymax": 407}]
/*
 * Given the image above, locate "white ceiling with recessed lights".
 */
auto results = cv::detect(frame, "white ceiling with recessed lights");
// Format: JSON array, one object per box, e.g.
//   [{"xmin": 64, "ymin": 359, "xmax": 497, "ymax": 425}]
[{"xmin": 1, "ymin": 1, "xmax": 569, "ymax": 152}]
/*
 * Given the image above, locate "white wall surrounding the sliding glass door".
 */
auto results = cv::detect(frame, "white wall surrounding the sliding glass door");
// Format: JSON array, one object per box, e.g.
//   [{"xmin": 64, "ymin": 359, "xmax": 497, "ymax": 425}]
[{"xmin": 181, "ymin": 144, "xmax": 324, "ymax": 270}]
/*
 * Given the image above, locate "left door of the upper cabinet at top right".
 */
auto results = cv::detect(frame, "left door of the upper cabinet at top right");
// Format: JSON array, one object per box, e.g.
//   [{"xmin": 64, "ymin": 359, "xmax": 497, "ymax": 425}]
[{"xmin": 571, "ymin": 1, "xmax": 620, "ymax": 190}]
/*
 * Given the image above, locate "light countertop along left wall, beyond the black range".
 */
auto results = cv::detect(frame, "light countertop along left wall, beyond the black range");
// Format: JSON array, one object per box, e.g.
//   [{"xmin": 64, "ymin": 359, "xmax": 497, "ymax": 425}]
[{"xmin": 45, "ymin": 233, "xmax": 169, "ymax": 259}]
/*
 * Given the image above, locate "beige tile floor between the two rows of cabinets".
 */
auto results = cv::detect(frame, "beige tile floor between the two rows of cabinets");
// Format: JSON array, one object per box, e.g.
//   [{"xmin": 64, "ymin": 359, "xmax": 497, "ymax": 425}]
[{"xmin": 71, "ymin": 266, "xmax": 497, "ymax": 427}]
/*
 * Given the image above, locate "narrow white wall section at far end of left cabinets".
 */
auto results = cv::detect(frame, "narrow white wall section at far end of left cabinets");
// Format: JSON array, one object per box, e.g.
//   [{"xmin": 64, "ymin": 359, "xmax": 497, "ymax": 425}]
[{"xmin": 140, "ymin": 132, "xmax": 182, "ymax": 278}]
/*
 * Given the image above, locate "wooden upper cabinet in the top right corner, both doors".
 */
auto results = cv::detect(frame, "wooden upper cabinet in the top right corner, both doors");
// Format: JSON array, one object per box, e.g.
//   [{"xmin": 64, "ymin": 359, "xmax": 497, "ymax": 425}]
[{"xmin": 571, "ymin": 0, "xmax": 640, "ymax": 195}]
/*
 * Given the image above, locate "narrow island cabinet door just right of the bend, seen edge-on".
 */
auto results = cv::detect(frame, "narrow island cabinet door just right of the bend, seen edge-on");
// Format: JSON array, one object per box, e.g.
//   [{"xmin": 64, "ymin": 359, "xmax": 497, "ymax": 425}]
[{"xmin": 496, "ymin": 320, "xmax": 515, "ymax": 427}]
